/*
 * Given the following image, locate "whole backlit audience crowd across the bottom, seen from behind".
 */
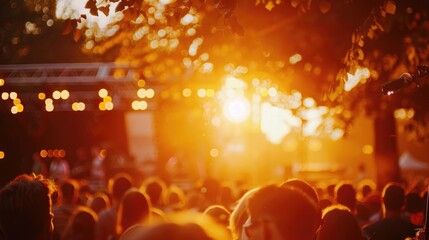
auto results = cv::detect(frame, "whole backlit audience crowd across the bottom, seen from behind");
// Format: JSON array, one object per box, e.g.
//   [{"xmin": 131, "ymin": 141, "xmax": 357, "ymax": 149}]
[{"xmin": 0, "ymin": 157, "xmax": 427, "ymax": 240}]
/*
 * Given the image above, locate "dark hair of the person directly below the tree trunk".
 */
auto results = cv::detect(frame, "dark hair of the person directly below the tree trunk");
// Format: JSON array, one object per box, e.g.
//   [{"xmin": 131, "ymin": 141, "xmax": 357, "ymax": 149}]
[{"xmin": 382, "ymin": 182, "xmax": 405, "ymax": 211}]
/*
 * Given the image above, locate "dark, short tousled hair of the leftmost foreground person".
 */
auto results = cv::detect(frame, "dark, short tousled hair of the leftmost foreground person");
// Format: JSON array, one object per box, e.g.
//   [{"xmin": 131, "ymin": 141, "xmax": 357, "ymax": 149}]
[{"xmin": 0, "ymin": 174, "xmax": 55, "ymax": 240}]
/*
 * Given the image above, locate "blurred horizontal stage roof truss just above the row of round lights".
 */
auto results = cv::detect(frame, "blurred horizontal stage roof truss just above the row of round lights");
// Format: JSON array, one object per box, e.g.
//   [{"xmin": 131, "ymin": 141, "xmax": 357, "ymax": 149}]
[{"xmin": 0, "ymin": 62, "xmax": 160, "ymax": 111}]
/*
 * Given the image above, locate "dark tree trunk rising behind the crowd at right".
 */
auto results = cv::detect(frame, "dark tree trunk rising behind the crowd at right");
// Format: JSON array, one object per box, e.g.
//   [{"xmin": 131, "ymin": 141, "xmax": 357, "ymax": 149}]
[{"xmin": 374, "ymin": 111, "xmax": 401, "ymax": 190}]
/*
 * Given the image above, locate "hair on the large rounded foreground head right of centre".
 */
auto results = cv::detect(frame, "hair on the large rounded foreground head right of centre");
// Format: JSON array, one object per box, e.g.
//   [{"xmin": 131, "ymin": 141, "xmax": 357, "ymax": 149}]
[{"xmin": 247, "ymin": 185, "xmax": 320, "ymax": 240}]
